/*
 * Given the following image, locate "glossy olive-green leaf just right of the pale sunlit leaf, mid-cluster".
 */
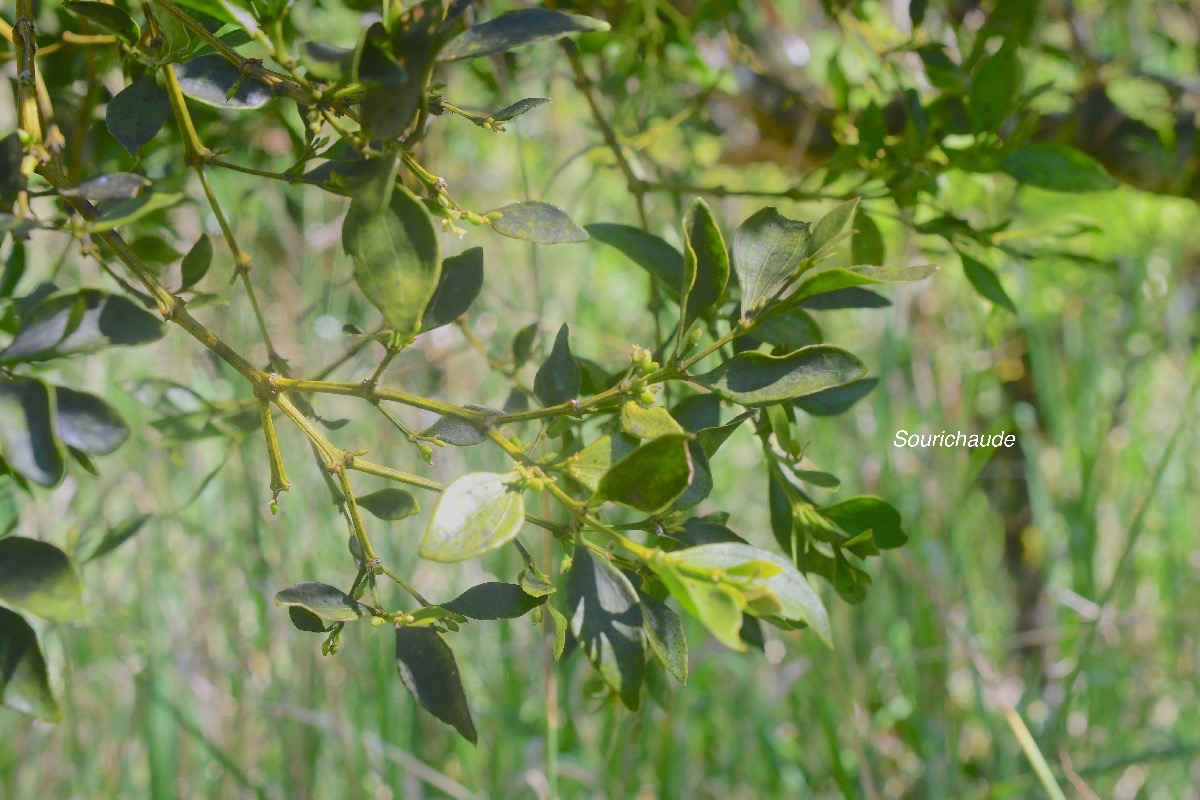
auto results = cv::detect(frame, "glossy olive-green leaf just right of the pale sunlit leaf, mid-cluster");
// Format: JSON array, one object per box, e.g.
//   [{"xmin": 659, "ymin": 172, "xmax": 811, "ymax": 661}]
[{"xmin": 595, "ymin": 433, "xmax": 694, "ymax": 513}]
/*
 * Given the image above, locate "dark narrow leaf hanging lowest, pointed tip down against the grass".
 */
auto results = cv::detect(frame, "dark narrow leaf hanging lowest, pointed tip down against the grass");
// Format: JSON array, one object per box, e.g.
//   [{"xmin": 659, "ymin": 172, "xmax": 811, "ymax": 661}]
[{"xmin": 396, "ymin": 626, "xmax": 478, "ymax": 745}]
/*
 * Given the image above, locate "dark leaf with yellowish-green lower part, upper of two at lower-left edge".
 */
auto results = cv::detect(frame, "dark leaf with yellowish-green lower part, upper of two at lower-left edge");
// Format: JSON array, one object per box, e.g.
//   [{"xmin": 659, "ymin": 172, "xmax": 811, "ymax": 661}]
[{"xmin": 0, "ymin": 536, "xmax": 83, "ymax": 622}]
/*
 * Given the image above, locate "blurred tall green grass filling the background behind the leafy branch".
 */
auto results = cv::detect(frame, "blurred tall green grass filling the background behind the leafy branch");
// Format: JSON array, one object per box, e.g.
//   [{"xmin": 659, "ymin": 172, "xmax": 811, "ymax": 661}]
[{"xmin": 0, "ymin": 20, "xmax": 1200, "ymax": 800}]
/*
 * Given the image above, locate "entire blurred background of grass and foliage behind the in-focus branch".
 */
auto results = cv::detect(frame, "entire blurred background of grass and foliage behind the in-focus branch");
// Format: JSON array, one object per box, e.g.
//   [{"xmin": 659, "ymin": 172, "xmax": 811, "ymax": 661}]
[{"xmin": 0, "ymin": 1, "xmax": 1200, "ymax": 799}]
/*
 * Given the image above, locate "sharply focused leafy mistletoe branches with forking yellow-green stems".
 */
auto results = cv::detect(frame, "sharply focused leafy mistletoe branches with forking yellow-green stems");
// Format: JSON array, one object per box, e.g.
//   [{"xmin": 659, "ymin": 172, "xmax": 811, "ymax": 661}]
[{"xmin": 0, "ymin": 0, "xmax": 932, "ymax": 741}]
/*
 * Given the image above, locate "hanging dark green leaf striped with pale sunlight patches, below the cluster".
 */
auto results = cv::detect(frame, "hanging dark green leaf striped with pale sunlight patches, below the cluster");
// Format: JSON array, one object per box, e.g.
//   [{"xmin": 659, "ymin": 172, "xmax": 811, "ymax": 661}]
[{"xmin": 566, "ymin": 546, "xmax": 646, "ymax": 710}]
